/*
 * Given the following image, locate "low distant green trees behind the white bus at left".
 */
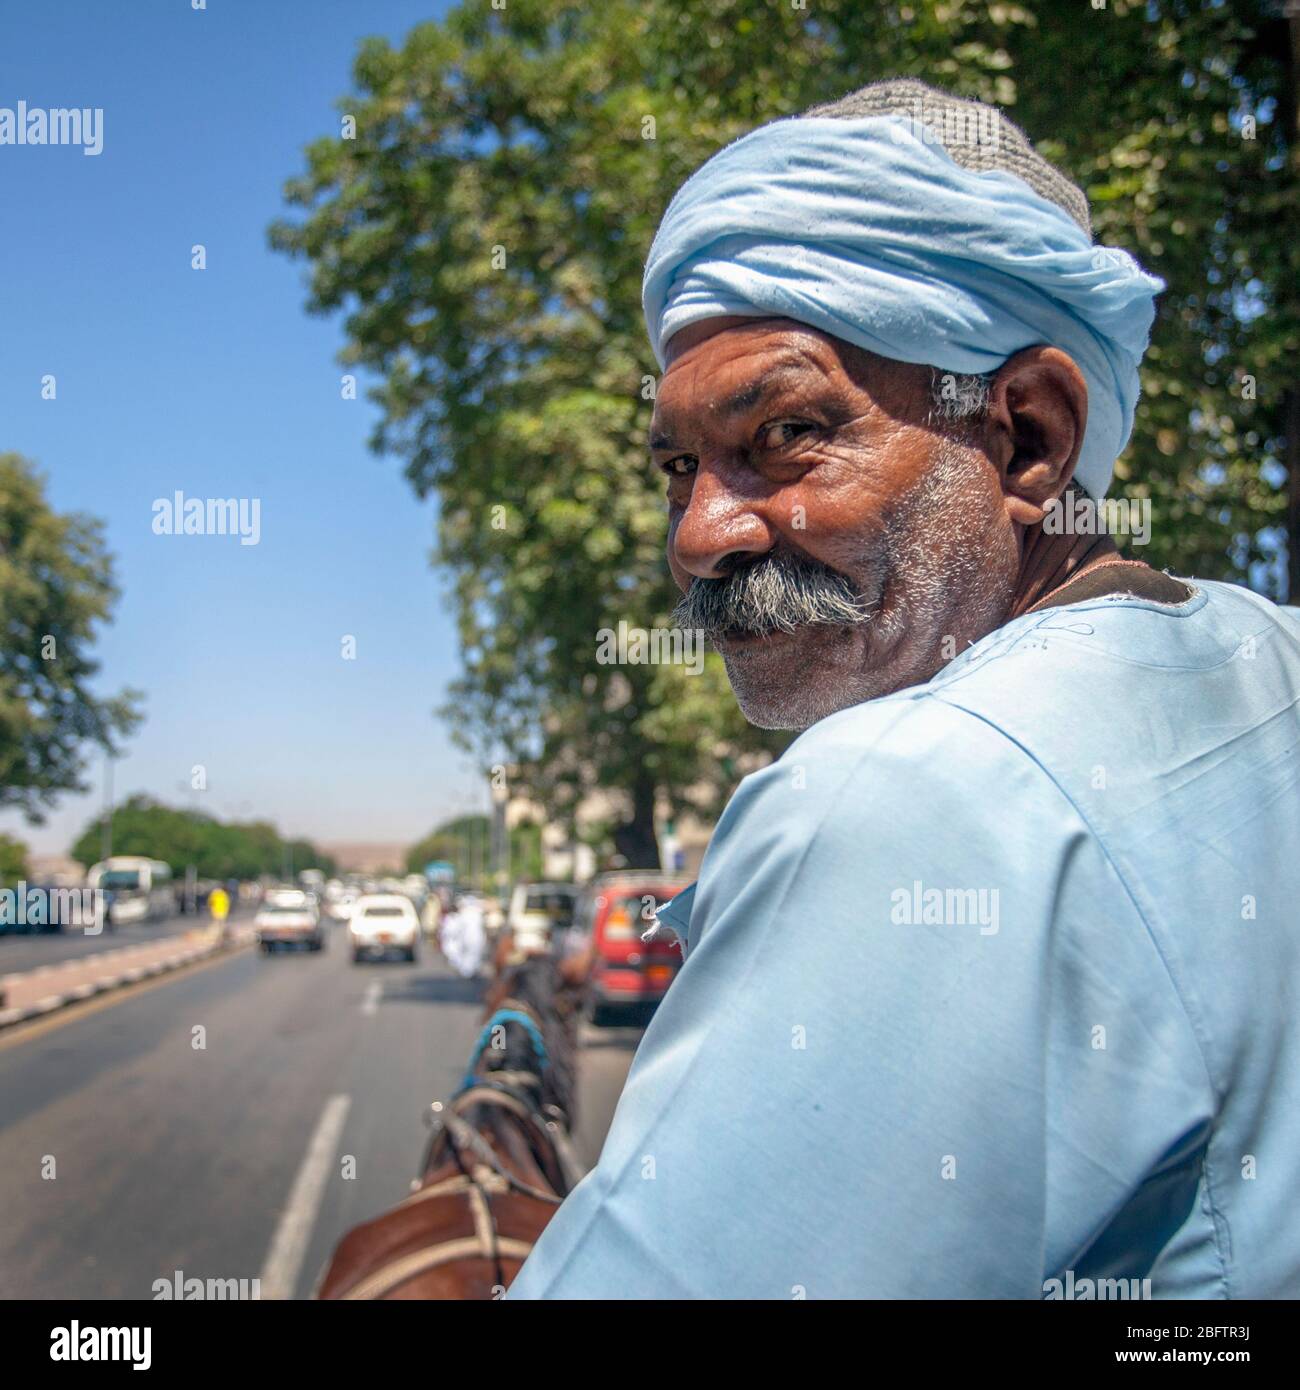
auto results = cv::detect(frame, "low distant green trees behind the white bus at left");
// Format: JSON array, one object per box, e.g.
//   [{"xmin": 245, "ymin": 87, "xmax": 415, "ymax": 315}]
[{"xmin": 71, "ymin": 796, "xmax": 335, "ymax": 878}]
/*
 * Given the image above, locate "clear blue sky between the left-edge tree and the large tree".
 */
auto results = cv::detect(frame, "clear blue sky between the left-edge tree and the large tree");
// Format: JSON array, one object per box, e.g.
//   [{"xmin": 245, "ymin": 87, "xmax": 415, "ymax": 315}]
[{"xmin": 0, "ymin": 0, "xmax": 485, "ymax": 852}]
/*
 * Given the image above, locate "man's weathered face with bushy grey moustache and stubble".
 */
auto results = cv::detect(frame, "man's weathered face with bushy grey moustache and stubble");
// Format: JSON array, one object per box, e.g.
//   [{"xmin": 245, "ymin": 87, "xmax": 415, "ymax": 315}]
[{"xmin": 651, "ymin": 318, "xmax": 1018, "ymax": 728}]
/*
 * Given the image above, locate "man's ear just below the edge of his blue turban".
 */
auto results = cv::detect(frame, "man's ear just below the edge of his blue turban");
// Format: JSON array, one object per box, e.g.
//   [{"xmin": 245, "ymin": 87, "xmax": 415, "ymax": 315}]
[{"xmin": 986, "ymin": 348, "xmax": 1087, "ymax": 525}]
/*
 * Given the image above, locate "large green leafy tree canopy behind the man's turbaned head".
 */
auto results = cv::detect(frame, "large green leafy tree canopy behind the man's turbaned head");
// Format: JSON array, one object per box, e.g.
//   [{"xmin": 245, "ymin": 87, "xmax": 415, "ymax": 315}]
[{"xmin": 271, "ymin": 0, "xmax": 1300, "ymax": 862}]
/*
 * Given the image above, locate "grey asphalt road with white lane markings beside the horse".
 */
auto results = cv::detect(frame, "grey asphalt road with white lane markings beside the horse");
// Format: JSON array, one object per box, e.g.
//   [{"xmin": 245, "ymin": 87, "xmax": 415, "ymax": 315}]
[{"xmin": 0, "ymin": 931, "xmax": 638, "ymax": 1298}]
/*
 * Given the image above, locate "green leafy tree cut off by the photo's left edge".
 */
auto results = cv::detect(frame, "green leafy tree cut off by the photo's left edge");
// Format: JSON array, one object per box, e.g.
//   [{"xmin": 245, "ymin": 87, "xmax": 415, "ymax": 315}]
[{"xmin": 0, "ymin": 453, "xmax": 139, "ymax": 824}]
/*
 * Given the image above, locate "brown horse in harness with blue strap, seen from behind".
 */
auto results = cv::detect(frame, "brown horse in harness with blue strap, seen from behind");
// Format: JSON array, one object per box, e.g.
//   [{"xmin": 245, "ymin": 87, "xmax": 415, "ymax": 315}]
[{"xmin": 320, "ymin": 956, "xmax": 584, "ymax": 1300}]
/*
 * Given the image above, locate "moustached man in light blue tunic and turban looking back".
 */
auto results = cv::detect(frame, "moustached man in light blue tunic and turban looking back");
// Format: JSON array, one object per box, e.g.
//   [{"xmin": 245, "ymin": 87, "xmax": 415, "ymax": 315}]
[{"xmin": 512, "ymin": 82, "xmax": 1300, "ymax": 1298}]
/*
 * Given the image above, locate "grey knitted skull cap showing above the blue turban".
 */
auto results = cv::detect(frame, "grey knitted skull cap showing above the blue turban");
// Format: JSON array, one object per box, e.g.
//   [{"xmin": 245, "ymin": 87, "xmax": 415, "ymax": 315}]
[{"xmin": 804, "ymin": 78, "xmax": 1093, "ymax": 240}]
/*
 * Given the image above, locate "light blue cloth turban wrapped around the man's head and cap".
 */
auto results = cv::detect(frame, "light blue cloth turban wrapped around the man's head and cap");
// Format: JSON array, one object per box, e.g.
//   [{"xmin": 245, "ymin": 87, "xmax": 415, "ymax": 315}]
[{"xmin": 642, "ymin": 115, "xmax": 1164, "ymax": 498}]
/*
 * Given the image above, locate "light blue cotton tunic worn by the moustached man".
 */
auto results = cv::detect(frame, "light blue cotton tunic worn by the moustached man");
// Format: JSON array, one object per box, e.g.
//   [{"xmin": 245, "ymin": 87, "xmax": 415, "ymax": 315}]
[{"xmin": 510, "ymin": 582, "xmax": 1300, "ymax": 1298}]
